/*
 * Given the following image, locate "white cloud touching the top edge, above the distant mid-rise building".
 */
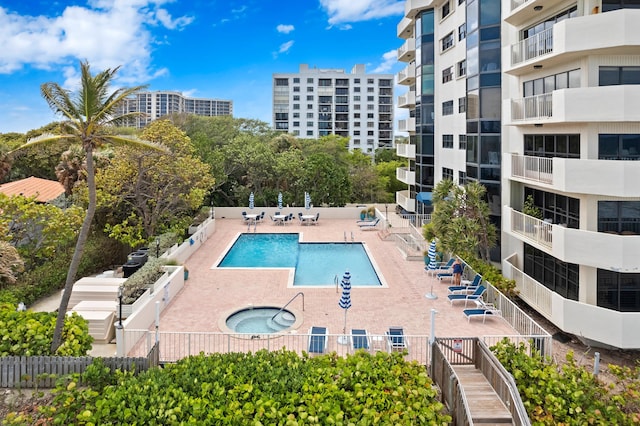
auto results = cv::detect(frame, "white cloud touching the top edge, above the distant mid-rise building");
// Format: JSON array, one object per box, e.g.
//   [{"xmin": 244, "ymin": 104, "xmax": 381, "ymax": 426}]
[{"xmin": 320, "ymin": 0, "xmax": 405, "ymax": 25}]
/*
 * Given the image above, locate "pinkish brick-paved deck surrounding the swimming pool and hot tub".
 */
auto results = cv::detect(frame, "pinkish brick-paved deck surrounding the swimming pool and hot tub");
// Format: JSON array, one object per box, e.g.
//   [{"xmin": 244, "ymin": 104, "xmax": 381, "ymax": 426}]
[{"xmin": 160, "ymin": 218, "xmax": 517, "ymax": 337}]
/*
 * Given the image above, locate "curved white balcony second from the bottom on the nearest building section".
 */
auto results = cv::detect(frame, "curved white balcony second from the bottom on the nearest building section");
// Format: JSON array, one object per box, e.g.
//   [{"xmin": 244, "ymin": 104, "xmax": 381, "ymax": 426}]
[{"xmin": 502, "ymin": 206, "xmax": 640, "ymax": 272}]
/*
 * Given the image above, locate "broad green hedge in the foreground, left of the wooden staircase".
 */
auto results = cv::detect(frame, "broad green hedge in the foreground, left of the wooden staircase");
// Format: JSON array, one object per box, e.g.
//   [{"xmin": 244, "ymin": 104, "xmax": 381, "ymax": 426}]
[{"xmin": 5, "ymin": 350, "xmax": 451, "ymax": 425}]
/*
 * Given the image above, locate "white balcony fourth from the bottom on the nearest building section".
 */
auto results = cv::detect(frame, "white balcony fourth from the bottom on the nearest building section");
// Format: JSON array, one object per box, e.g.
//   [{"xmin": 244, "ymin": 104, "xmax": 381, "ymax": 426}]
[{"xmin": 505, "ymin": 85, "xmax": 640, "ymax": 125}]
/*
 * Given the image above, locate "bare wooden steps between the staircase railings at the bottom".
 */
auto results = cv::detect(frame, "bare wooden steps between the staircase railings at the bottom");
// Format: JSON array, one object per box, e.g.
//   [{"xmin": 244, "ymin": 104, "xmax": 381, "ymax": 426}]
[{"xmin": 453, "ymin": 365, "xmax": 513, "ymax": 425}]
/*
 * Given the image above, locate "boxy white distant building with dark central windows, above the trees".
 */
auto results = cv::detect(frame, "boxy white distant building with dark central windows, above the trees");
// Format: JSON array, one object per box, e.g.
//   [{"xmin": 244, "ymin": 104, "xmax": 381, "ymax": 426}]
[{"xmin": 272, "ymin": 64, "xmax": 393, "ymax": 154}]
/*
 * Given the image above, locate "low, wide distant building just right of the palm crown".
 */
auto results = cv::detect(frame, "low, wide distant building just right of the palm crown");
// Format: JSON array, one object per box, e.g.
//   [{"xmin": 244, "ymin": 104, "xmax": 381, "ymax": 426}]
[{"xmin": 120, "ymin": 91, "xmax": 233, "ymax": 128}]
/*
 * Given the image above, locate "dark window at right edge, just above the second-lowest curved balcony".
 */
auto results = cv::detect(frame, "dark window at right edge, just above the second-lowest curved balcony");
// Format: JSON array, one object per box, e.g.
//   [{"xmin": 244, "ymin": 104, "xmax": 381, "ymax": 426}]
[{"xmin": 598, "ymin": 201, "xmax": 640, "ymax": 235}]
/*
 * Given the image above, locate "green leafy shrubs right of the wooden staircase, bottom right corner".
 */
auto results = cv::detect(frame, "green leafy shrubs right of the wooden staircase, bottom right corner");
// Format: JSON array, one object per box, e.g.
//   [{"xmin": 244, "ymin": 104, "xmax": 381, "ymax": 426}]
[{"xmin": 491, "ymin": 339, "xmax": 640, "ymax": 425}]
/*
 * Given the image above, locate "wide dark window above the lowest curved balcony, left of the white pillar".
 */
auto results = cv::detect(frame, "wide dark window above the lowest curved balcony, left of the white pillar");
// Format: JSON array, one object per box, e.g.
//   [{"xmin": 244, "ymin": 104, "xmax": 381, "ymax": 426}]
[{"xmin": 524, "ymin": 243, "xmax": 580, "ymax": 300}]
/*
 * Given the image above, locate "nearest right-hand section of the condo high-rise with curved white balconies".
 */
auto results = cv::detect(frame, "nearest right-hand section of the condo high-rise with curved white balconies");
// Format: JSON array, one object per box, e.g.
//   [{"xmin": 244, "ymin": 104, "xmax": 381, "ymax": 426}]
[{"xmin": 500, "ymin": 0, "xmax": 640, "ymax": 349}]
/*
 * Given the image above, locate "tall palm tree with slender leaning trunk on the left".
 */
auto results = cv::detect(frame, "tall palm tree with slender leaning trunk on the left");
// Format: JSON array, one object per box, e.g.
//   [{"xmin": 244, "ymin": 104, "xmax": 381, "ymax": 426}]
[{"xmin": 13, "ymin": 61, "xmax": 162, "ymax": 353}]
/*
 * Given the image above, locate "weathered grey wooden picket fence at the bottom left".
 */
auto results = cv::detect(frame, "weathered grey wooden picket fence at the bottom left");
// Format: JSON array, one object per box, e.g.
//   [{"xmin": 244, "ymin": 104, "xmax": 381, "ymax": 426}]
[{"xmin": 0, "ymin": 344, "xmax": 159, "ymax": 388}]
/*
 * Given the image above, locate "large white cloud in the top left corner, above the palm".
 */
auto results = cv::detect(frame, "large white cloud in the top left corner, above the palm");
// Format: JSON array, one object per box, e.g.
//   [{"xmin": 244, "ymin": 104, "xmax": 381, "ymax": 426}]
[{"xmin": 0, "ymin": 0, "xmax": 193, "ymax": 86}]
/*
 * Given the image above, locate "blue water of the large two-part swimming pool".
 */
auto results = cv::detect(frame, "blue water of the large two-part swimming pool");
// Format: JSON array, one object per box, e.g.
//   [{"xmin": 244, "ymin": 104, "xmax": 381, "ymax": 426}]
[{"xmin": 218, "ymin": 234, "xmax": 381, "ymax": 286}]
